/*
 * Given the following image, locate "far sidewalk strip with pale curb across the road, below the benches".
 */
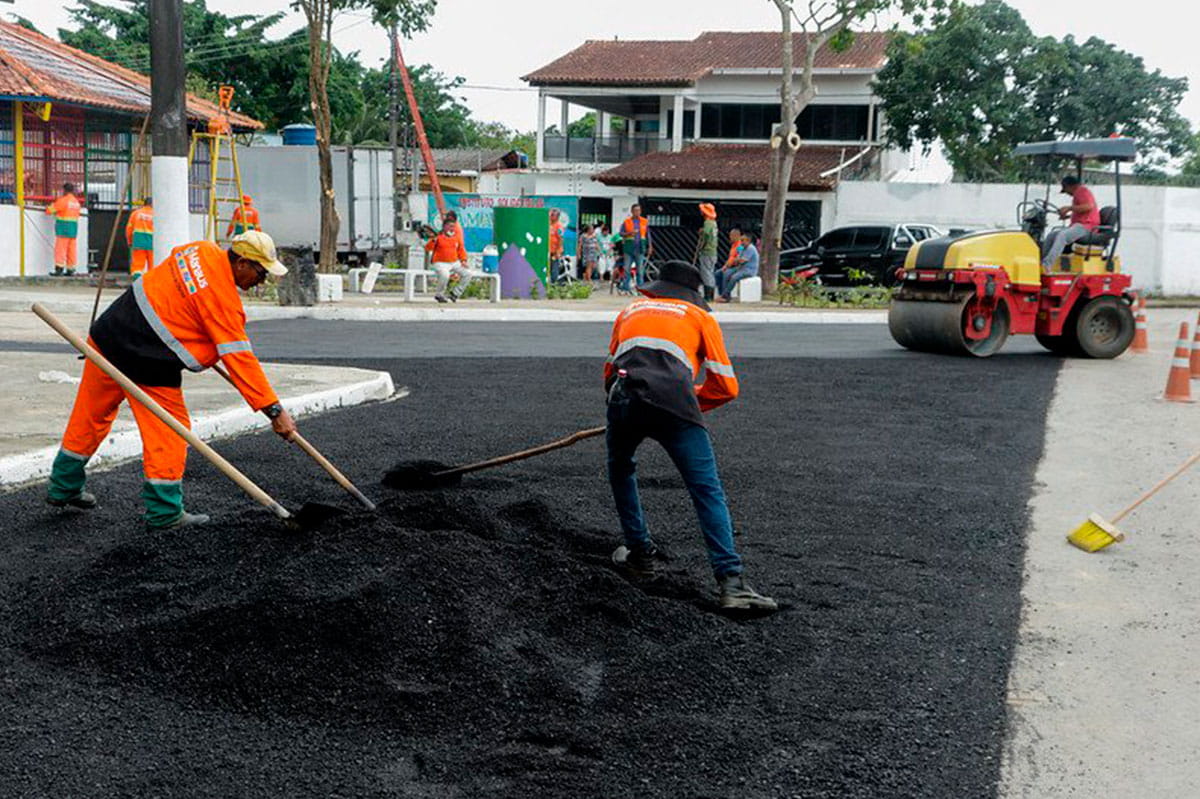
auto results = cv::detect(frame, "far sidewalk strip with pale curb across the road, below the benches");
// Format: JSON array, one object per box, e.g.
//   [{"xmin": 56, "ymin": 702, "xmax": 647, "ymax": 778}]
[{"xmin": 0, "ymin": 280, "xmax": 887, "ymax": 324}]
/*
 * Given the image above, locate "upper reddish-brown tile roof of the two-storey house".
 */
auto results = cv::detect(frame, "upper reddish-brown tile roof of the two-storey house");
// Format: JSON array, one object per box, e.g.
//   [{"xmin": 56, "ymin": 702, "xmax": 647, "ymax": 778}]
[{"xmin": 522, "ymin": 32, "xmax": 889, "ymax": 86}]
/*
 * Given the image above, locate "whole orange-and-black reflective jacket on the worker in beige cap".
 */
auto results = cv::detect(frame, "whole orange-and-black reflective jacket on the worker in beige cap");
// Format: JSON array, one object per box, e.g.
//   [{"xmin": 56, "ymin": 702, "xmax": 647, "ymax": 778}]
[{"xmin": 91, "ymin": 241, "xmax": 278, "ymax": 410}]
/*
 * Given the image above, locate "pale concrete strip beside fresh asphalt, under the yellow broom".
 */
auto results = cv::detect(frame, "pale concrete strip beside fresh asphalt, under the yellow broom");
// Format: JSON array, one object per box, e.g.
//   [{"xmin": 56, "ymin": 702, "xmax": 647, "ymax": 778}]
[{"xmin": 997, "ymin": 308, "xmax": 1200, "ymax": 799}]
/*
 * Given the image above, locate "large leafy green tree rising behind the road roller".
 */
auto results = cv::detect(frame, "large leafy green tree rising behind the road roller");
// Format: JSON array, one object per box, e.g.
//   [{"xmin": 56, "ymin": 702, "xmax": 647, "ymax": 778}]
[{"xmin": 876, "ymin": 0, "xmax": 1194, "ymax": 180}]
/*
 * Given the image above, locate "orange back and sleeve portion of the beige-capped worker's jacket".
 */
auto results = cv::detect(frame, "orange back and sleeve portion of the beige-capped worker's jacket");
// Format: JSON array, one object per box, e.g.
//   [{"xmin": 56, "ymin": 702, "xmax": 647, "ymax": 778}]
[{"xmin": 130, "ymin": 241, "xmax": 278, "ymax": 410}]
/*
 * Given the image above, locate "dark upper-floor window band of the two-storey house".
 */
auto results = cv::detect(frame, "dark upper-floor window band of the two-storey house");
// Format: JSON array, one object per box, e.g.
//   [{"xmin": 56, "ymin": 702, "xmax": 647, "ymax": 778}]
[{"xmin": 700, "ymin": 103, "xmax": 871, "ymax": 142}]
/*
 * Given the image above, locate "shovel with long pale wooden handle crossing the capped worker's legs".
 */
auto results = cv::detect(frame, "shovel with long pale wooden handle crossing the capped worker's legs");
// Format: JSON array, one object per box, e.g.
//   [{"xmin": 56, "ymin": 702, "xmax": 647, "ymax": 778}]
[{"xmin": 32, "ymin": 302, "xmax": 343, "ymax": 530}]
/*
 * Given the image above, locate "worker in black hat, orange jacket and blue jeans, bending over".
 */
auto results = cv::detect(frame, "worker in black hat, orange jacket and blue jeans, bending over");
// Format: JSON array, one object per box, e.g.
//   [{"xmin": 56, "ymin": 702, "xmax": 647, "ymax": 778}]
[{"xmin": 604, "ymin": 260, "xmax": 778, "ymax": 611}]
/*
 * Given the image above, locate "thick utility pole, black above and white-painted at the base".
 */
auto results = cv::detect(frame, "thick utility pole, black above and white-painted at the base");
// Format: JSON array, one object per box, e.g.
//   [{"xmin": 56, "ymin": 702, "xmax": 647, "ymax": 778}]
[{"xmin": 150, "ymin": 0, "xmax": 191, "ymax": 264}]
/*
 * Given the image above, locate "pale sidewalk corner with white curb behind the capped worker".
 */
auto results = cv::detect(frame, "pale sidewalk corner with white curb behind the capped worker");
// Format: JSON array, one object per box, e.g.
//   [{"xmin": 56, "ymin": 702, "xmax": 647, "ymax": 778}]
[{"xmin": 0, "ymin": 347, "xmax": 396, "ymax": 487}]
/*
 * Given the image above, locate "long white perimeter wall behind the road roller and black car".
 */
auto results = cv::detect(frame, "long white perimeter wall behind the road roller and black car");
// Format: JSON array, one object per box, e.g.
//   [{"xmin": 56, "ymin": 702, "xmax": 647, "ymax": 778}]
[{"xmin": 822, "ymin": 181, "xmax": 1200, "ymax": 295}]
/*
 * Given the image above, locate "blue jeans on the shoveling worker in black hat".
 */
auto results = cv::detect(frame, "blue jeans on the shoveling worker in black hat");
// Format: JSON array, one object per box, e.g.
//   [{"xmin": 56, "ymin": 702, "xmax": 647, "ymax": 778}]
[{"xmin": 606, "ymin": 397, "xmax": 742, "ymax": 577}]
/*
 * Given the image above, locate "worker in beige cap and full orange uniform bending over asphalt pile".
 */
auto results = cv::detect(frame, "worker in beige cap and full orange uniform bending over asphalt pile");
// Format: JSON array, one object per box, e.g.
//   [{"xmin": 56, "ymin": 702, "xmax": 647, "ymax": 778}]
[{"xmin": 47, "ymin": 230, "xmax": 296, "ymax": 528}]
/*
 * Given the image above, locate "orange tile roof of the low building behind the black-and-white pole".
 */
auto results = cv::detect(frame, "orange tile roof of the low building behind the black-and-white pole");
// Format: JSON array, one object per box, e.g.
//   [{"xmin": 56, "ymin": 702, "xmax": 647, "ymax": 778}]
[{"xmin": 0, "ymin": 22, "xmax": 263, "ymax": 131}]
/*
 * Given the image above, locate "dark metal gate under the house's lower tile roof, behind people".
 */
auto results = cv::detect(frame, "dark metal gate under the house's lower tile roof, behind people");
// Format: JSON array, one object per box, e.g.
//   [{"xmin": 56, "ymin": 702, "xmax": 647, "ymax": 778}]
[{"xmin": 638, "ymin": 197, "xmax": 821, "ymax": 263}]
